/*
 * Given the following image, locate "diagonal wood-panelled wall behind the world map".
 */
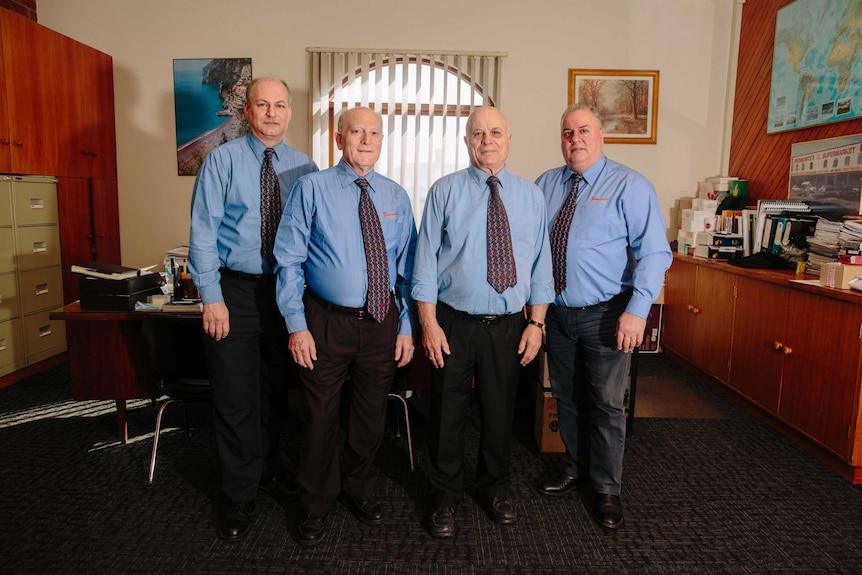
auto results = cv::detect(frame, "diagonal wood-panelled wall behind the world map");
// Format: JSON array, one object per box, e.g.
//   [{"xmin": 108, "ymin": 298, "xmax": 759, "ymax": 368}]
[{"xmin": 729, "ymin": 0, "xmax": 862, "ymax": 204}]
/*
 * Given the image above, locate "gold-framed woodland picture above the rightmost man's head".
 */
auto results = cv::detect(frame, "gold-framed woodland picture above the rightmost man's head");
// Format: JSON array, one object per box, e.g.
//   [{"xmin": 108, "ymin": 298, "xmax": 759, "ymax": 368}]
[{"xmin": 569, "ymin": 68, "xmax": 659, "ymax": 144}]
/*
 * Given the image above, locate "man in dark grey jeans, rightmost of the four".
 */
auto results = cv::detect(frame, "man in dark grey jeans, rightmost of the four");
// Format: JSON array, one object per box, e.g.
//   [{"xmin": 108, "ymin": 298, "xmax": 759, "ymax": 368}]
[{"xmin": 536, "ymin": 104, "xmax": 671, "ymax": 529}]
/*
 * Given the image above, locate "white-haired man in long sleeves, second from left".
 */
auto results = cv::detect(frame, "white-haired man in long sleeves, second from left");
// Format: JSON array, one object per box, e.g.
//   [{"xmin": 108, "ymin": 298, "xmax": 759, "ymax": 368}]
[{"xmin": 275, "ymin": 108, "xmax": 416, "ymax": 546}]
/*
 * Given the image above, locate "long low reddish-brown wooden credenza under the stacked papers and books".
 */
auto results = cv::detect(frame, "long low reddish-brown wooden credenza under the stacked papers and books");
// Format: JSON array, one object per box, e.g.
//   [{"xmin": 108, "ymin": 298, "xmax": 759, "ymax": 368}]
[{"xmin": 662, "ymin": 254, "xmax": 862, "ymax": 483}]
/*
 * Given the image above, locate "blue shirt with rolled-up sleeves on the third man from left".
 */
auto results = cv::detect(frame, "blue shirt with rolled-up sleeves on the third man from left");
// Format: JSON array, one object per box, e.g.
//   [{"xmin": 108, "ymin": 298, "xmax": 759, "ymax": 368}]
[{"xmin": 412, "ymin": 166, "xmax": 554, "ymax": 315}]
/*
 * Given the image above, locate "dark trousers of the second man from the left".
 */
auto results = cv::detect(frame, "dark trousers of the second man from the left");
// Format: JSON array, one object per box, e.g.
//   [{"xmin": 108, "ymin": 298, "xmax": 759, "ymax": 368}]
[{"xmin": 297, "ymin": 295, "xmax": 398, "ymax": 515}]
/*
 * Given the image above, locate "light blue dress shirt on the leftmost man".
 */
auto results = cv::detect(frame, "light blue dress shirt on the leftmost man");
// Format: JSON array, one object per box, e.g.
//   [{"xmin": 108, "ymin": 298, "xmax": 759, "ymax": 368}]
[{"xmin": 189, "ymin": 134, "xmax": 317, "ymax": 304}]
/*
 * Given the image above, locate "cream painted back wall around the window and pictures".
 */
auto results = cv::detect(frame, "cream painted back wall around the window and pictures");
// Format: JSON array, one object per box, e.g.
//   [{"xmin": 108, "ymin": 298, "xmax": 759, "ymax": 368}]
[{"xmin": 37, "ymin": 0, "xmax": 736, "ymax": 266}]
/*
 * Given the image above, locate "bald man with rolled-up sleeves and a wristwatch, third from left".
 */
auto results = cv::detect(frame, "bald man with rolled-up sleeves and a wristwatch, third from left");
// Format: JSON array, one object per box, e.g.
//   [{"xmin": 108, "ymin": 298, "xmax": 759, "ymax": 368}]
[{"xmin": 412, "ymin": 108, "xmax": 554, "ymax": 537}]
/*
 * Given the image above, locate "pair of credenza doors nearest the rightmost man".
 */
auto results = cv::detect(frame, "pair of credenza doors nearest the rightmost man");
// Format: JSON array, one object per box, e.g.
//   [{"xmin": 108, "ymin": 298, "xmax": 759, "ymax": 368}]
[{"xmin": 662, "ymin": 259, "xmax": 736, "ymax": 383}]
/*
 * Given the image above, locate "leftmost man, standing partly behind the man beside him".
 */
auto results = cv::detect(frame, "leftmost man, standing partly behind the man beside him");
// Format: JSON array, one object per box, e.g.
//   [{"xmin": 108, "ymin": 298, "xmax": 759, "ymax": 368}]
[{"xmin": 189, "ymin": 78, "xmax": 317, "ymax": 540}]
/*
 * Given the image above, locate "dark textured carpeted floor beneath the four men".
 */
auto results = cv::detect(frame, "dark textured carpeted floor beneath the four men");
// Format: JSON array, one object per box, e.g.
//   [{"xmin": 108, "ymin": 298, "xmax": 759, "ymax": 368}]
[{"xmin": 0, "ymin": 354, "xmax": 862, "ymax": 575}]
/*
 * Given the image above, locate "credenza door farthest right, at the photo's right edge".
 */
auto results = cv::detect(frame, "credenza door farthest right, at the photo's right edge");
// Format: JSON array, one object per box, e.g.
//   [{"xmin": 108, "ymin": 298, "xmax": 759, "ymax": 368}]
[{"xmin": 778, "ymin": 293, "xmax": 862, "ymax": 461}]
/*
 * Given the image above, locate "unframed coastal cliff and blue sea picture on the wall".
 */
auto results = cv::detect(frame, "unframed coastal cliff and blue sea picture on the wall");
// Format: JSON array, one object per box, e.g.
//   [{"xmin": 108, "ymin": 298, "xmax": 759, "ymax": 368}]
[{"xmin": 174, "ymin": 58, "xmax": 252, "ymax": 176}]
